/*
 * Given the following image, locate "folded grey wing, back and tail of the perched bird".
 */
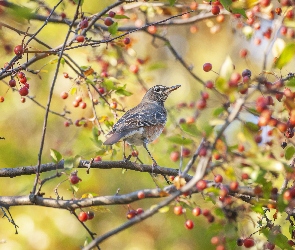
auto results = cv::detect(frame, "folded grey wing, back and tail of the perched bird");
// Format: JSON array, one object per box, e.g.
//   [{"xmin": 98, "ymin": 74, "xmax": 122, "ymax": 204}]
[{"xmin": 104, "ymin": 102, "xmax": 167, "ymax": 145}]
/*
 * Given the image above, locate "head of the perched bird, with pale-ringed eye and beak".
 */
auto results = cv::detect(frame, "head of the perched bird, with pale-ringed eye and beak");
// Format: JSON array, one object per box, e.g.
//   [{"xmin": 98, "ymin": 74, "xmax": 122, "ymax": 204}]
[{"xmin": 143, "ymin": 85, "xmax": 181, "ymax": 102}]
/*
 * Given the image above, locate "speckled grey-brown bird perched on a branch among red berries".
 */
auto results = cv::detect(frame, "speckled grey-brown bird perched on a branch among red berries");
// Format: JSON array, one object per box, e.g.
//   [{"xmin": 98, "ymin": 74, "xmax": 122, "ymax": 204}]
[{"xmin": 103, "ymin": 85, "xmax": 181, "ymax": 166}]
